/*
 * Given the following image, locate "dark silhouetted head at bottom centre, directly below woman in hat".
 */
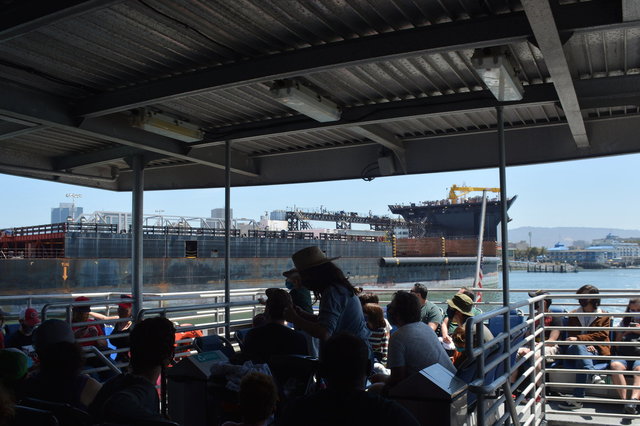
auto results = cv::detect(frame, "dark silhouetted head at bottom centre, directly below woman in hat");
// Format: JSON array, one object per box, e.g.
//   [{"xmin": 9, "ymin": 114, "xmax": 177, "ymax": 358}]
[{"xmin": 320, "ymin": 332, "xmax": 370, "ymax": 390}]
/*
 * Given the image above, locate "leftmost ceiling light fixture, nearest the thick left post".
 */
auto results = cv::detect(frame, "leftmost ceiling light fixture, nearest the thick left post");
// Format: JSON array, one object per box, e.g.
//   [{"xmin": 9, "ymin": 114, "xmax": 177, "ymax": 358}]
[{"xmin": 132, "ymin": 108, "xmax": 204, "ymax": 142}]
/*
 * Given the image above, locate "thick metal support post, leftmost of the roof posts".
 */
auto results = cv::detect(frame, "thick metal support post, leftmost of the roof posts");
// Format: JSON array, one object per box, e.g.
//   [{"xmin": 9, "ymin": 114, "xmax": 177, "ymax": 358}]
[{"xmin": 131, "ymin": 155, "xmax": 144, "ymax": 318}]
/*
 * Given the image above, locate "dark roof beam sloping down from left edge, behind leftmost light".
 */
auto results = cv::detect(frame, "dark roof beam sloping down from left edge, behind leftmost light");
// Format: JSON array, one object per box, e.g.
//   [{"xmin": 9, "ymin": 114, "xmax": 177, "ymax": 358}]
[{"xmin": 0, "ymin": 83, "xmax": 258, "ymax": 177}]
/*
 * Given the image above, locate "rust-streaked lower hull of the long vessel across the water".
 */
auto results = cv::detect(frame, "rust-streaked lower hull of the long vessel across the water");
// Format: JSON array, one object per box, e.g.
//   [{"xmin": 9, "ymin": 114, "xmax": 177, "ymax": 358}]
[{"xmin": 0, "ymin": 257, "xmax": 497, "ymax": 294}]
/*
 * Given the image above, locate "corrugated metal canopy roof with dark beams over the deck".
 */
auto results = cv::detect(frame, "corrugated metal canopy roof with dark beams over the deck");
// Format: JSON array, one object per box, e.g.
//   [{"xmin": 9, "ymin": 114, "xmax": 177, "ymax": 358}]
[{"xmin": 0, "ymin": 0, "xmax": 640, "ymax": 190}]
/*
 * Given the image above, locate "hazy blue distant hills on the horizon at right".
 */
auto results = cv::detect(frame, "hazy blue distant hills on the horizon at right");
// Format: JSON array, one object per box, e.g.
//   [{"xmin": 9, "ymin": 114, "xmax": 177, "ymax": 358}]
[{"xmin": 509, "ymin": 226, "xmax": 640, "ymax": 247}]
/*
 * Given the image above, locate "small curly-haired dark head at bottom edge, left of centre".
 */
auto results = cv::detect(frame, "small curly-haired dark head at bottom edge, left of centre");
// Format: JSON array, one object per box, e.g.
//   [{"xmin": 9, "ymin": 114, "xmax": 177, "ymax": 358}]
[{"xmin": 239, "ymin": 372, "xmax": 278, "ymax": 424}]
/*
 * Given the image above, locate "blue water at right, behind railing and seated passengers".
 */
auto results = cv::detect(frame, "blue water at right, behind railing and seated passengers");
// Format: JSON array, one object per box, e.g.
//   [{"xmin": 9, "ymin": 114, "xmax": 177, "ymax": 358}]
[{"xmin": 500, "ymin": 269, "xmax": 640, "ymax": 311}]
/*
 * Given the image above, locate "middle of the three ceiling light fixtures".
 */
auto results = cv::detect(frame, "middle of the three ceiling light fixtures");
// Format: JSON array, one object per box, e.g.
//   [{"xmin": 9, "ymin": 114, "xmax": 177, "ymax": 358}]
[{"xmin": 271, "ymin": 80, "xmax": 340, "ymax": 123}]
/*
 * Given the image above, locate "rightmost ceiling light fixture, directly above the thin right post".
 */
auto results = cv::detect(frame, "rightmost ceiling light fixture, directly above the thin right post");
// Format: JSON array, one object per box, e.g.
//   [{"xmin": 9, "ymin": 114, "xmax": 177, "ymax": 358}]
[{"xmin": 471, "ymin": 47, "xmax": 524, "ymax": 102}]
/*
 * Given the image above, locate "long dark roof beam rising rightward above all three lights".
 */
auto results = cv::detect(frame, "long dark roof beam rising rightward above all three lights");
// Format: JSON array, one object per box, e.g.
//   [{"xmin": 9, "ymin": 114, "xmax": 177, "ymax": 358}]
[{"xmin": 75, "ymin": 0, "xmax": 631, "ymax": 117}]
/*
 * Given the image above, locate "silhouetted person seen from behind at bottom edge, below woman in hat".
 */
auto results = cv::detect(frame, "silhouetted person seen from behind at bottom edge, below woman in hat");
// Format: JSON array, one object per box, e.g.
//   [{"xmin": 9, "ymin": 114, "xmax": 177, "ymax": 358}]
[{"xmin": 278, "ymin": 333, "xmax": 419, "ymax": 426}]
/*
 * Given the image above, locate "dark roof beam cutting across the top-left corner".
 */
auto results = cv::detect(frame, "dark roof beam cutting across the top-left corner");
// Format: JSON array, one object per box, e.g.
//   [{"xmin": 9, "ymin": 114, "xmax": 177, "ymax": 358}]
[{"xmin": 0, "ymin": 0, "xmax": 123, "ymax": 43}]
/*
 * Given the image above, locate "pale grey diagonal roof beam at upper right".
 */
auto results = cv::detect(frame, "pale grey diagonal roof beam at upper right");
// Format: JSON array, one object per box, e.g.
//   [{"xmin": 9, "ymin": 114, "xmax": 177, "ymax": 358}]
[{"xmin": 522, "ymin": 0, "xmax": 589, "ymax": 148}]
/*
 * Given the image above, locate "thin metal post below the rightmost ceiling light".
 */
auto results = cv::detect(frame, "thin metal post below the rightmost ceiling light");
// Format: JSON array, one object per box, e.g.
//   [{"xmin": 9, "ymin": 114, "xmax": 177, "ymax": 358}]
[{"xmin": 496, "ymin": 106, "xmax": 520, "ymax": 426}]
